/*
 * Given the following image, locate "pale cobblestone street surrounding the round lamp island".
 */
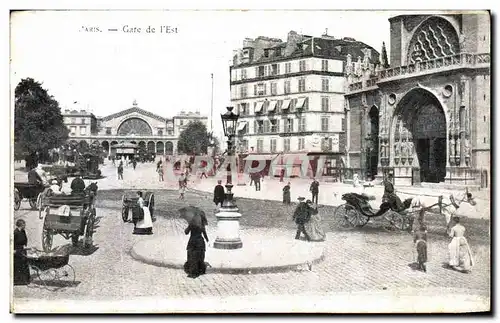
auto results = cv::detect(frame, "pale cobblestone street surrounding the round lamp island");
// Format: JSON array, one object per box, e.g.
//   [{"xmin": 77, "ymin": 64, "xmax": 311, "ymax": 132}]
[{"xmin": 14, "ymin": 164, "xmax": 490, "ymax": 312}]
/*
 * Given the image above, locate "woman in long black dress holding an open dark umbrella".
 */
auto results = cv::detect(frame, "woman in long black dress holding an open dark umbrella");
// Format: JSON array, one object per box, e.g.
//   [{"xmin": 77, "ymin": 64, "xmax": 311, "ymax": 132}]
[{"xmin": 184, "ymin": 212, "xmax": 208, "ymax": 278}]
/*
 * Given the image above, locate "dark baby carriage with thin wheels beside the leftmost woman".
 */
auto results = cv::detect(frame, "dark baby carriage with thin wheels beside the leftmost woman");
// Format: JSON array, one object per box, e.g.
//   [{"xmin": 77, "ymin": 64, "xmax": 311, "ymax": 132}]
[{"xmin": 26, "ymin": 249, "xmax": 76, "ymax": 287}]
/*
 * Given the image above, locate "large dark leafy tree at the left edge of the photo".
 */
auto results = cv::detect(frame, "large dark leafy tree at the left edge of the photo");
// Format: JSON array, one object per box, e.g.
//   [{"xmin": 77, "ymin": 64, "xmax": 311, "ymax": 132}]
[{"xmin": 14, "ymin": 78, "xmax": 69, "ymax": 161}]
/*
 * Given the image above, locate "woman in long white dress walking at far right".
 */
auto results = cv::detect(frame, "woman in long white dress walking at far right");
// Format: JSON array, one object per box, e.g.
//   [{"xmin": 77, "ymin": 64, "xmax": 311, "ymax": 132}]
[{"xmin": 448, "ymin": 216, "xmax": 474, "ymax": 272}]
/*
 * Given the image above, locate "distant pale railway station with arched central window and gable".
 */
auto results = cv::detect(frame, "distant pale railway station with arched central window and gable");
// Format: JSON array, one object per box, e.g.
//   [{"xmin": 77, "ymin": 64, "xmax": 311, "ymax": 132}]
[{"xmin": 62, "ymin": 101, "xmax": 208, "ymax": 155}]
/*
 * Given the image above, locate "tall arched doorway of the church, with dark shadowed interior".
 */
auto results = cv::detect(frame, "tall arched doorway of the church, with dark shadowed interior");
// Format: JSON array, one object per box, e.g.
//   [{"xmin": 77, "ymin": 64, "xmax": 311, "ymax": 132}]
[{"xmin": 392, "ymin": 89, "xmax": 447, "ymax": 183}]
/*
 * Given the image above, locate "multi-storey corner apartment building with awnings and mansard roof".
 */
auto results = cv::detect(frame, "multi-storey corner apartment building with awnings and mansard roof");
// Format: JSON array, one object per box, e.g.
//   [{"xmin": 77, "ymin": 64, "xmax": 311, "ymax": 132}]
[{"xmin": 230, "ymin": 31, "xmax": 379, "ymax": 176}]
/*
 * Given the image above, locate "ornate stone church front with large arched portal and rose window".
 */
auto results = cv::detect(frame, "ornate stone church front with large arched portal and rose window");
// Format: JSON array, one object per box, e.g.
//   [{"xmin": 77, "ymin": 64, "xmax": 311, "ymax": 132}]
[{"xmin": 345, "ymin": 12, "xmax": 491, "ymax": 187}]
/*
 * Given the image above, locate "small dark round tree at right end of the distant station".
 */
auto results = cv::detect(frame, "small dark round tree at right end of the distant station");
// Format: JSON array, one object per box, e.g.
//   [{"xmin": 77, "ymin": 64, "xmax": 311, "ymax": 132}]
[{"xmin": 177, "ymin": 121, "xmax": 209, "ymax": 154}]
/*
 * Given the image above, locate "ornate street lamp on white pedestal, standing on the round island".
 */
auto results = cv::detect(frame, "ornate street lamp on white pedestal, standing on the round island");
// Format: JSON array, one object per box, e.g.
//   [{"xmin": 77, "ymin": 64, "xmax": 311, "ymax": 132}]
[{"xmin": 214, "ymin": 107, "xmax": 243, "ymax": 249}]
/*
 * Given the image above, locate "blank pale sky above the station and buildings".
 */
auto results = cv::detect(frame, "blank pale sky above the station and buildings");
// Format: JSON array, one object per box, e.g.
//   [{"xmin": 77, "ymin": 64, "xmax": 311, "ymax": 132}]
[{"xmin": 10, "ymin": 10, "xmax": 410, "ymax": 132}]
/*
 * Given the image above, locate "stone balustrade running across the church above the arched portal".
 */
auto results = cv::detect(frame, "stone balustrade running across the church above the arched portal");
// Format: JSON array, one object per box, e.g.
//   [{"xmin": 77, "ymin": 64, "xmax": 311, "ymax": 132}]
[{"xmin": 348, "ymin": 53, "xmax": 491, "ymax": 92}]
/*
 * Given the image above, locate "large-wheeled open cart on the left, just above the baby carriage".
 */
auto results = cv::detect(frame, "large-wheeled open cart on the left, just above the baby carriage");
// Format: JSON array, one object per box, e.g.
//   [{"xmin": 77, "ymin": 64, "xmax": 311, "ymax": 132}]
[{"xmin": 39, "ymin": 194, "xmax": 96, "ymax": 251}]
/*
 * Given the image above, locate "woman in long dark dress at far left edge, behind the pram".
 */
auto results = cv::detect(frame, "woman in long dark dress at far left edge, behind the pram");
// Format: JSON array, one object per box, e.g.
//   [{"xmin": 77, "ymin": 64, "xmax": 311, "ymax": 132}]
[{"xmin": 14, "ymin": 219, "xmax": 31, "ymax": 285}]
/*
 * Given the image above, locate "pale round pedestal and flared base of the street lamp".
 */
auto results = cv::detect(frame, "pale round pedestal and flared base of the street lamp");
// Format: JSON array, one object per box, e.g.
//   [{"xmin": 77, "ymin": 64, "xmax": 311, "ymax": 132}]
[{"xmin": 214, "ymin": 184, "xmax": 243, "ymax": 249}]
